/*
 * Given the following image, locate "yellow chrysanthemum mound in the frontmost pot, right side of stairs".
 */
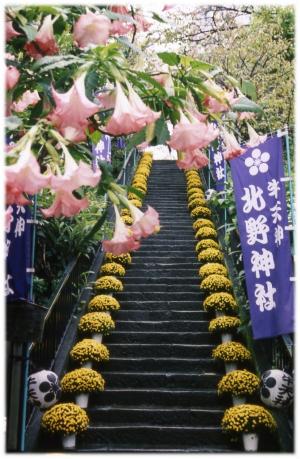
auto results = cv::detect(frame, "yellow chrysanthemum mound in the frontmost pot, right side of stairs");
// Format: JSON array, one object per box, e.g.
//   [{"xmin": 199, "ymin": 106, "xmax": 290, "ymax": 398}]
[{"xmin": 221, "ymin": 403, "xmax": 277, "ymax": 433}]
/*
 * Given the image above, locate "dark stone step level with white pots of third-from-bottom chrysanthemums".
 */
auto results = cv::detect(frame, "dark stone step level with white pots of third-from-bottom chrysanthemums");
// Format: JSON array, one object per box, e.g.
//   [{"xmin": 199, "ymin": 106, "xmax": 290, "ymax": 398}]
[{"xmin": 99, "ymin": 357, "xmax": 224, "ymax": 374}]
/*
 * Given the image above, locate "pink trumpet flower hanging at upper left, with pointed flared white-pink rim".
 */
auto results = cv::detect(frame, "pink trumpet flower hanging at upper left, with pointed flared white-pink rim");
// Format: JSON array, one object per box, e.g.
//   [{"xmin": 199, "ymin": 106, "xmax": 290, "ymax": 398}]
[{"xmin": 48, "ymin": 73, "xmax": 99, "ymax": 142}]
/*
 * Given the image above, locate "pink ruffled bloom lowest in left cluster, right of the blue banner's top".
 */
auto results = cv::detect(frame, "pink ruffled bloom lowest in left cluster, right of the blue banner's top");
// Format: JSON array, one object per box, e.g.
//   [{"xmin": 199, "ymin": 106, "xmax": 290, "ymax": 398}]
[{"xmin": 41, "ymin": 189, "xmax": 89, "ymax": 218}]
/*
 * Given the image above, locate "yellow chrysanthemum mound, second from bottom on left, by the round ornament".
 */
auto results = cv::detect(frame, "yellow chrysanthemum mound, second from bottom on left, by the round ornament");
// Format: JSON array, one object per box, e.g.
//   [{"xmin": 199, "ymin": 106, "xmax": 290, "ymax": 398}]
[{"xmin": 61, "ymin": 368, "xmax": 105, "ymax": 394}]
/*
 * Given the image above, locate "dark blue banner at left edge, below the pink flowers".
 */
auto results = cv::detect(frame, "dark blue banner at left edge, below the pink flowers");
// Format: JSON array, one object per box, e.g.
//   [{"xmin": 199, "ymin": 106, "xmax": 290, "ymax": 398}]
[{"xmin": 4, "ymin": 205, "xmax": 32, "ymax": 301}]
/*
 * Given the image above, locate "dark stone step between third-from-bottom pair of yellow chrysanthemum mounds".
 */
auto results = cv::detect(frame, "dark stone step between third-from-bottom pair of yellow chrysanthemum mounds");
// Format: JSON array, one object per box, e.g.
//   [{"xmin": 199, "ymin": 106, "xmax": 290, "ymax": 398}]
[{"xmin": 109, "ymin": 343, "xmax": 215, "ymax": 358}]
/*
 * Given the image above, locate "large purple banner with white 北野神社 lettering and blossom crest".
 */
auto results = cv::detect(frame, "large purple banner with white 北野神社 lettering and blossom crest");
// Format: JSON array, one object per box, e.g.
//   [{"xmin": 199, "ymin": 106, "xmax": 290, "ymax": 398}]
[{"xmin": 230, "ymin": 137, "xmax": 294, "ymax": 339}]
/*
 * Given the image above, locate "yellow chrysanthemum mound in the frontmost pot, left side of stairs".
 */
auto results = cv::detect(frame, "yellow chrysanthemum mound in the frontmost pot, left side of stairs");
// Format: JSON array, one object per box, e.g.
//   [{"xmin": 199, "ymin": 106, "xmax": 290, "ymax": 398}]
[{"xmin": 41, "ymin": 403, "xmax": 89, "ymax": 435}]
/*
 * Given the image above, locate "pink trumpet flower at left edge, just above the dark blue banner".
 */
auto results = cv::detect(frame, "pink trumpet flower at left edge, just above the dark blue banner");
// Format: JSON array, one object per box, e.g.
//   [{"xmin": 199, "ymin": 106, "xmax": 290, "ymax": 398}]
[{"xmin": 5, "ymin": 140, "xmax": 51, "ymax": 204}]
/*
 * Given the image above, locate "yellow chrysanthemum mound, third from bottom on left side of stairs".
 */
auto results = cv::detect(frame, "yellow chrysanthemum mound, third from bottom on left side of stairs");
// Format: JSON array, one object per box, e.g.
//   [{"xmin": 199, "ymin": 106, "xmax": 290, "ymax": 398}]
[{"xmin": 70, "ymin": 339, "xmax": 109, "ymax": 363}]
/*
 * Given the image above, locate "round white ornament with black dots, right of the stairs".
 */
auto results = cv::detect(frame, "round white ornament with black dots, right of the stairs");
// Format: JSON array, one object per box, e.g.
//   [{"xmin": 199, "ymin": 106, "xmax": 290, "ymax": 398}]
[{"xmin": 260, "ymin": 370, "xmax": 293, "ymax": 408}]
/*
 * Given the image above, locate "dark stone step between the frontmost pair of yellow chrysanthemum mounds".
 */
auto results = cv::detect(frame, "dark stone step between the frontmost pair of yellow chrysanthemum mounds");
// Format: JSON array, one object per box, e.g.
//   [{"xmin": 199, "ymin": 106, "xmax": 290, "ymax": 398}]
[{"xmin": 87, "ymin": 406, "xmax": 223, "ymax": 426}]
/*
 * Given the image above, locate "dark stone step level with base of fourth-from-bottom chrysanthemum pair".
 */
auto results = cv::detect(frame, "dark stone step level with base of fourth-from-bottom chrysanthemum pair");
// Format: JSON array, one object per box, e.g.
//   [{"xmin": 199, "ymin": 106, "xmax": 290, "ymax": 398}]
[{"xmin": 103, "ymin": 330, "xmax": 219, "ymax": 347}]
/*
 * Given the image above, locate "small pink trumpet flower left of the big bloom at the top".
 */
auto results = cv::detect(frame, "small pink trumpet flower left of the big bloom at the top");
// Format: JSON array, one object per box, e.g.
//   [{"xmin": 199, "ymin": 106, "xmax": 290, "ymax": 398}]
[{"xmin": 25, "ymin": 14, "xmax": 59, "ymax": 59}]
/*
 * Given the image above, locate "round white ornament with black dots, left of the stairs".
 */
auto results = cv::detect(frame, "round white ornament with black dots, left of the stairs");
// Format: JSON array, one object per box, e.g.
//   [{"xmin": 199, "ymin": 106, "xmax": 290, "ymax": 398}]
[{"xmin": 28, "ymin": 370, "xmax": 61, "ymax": 410}]
